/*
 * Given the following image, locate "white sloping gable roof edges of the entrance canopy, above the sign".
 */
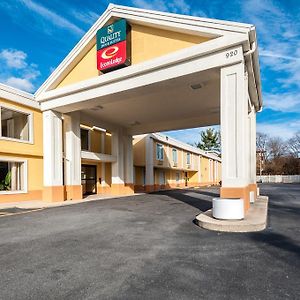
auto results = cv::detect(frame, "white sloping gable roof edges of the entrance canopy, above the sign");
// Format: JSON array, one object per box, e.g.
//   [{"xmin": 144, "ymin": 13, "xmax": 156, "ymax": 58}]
[{"xmin": 35, "ymin": 4, "xmax": 255, "ymax": 96}]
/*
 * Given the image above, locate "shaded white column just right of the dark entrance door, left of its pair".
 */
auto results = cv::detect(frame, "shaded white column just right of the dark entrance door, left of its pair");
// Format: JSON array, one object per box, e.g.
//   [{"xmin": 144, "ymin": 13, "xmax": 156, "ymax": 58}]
[{"xmin": 111, "ymin": 129, "xmax": 125, "ymax": 184}]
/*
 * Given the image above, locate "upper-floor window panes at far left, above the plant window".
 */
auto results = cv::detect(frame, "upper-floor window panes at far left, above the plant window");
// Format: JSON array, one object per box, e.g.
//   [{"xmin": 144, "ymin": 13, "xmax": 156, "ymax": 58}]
[{"xmin": 0, "ymin": 107, "xmax": 31, "ymax": 141}]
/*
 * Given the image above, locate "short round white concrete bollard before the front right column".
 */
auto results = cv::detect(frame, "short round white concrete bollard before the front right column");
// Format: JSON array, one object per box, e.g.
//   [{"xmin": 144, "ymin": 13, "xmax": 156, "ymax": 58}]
[{"xmin": 212, "ymin": 198, "xmax": 245, "ymax": 220}]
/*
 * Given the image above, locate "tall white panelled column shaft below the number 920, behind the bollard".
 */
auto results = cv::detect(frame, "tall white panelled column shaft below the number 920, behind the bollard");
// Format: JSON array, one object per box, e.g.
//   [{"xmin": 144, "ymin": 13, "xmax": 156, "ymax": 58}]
[{"xmin": 221, "ymin": 63, "xmax": 249, "ymax": 187}]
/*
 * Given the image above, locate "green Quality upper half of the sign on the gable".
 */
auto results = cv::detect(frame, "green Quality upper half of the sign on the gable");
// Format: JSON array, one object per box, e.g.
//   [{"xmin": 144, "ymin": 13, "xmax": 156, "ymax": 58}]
[{"xmin": 97, "ymin": 19, "xmax": 126, "ymax": 50}]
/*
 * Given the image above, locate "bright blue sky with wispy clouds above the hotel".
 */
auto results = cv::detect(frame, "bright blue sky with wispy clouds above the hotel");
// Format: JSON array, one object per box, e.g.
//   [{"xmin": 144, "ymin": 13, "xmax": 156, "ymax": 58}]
[{"xmin": 0, "ymin": 0, "xmax": 300, "ymax": 142}]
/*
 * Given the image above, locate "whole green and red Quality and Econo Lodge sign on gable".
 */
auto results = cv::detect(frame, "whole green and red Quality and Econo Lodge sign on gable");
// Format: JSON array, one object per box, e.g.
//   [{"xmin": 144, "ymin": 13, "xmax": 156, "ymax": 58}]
[{"xmin": 97, "ymin": 19, "xmax": 131, "ymax": 73}]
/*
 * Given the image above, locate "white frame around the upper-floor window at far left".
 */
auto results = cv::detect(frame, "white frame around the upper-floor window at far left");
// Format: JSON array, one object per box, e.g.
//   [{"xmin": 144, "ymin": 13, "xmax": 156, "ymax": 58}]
[{"xmin": 0, "ymin": 103, "xmax": 34, "ymax": 144}]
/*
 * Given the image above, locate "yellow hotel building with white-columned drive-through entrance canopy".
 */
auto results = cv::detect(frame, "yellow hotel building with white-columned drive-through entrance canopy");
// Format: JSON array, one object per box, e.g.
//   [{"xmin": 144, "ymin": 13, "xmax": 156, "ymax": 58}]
[{"xmin": 0, "ymin": 4, "xmax": 262, "ymax": 218}]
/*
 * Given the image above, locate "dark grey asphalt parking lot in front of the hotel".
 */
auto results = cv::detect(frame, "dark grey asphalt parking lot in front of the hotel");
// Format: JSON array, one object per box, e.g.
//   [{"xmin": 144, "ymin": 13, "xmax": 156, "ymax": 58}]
[{"xmin": 0, "ymin": 184, "xmax": 300, "ymax": 300}]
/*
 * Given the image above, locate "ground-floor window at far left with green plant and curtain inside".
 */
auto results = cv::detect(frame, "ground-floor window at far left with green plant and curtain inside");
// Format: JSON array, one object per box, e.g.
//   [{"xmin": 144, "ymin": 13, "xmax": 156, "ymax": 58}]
[{"xmin": 0, "ymin": 160, "xmax": 27, "ymax": 193}]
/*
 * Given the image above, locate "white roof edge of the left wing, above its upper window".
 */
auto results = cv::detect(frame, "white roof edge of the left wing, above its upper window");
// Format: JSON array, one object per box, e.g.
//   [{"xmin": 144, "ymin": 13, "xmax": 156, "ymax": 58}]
[{"xmin": 0, "ymin": 83, "xmax": 40, "ymax": 109}]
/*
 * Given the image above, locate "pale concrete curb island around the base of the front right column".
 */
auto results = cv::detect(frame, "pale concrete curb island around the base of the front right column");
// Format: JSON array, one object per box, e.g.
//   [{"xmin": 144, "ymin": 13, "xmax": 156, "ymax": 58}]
[{"xmin": 195, "ymin": 196, "xmax": 269, "ymax": 232}]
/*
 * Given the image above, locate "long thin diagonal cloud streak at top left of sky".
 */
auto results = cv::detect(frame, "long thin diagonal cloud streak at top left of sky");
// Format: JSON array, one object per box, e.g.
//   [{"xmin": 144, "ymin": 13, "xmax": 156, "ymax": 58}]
[{"xmin": 20, "ymin": 0, "xmax": 84, "ymax": 35}]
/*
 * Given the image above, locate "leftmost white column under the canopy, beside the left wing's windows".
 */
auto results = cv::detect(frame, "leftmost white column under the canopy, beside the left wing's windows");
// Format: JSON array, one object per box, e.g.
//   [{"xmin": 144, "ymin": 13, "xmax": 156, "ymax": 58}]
[{"xmin": 43, "ymin": 110, "xmax": 63, "ymax": 186}]
